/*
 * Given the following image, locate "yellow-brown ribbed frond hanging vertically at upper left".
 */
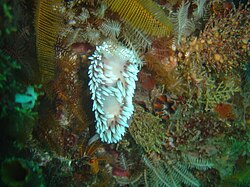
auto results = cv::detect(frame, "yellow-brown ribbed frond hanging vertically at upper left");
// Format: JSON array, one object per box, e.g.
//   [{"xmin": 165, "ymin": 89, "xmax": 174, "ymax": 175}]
[{"xmin": 35, "ymin": 0, "xmax": 63, "ymax": 83}]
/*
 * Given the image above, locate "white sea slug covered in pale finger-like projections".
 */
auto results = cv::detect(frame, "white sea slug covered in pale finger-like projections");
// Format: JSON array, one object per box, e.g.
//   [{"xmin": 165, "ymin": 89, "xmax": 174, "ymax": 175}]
[{"xmin": 88, "ymin": 42, "xmax": 141, "ymax": 143}]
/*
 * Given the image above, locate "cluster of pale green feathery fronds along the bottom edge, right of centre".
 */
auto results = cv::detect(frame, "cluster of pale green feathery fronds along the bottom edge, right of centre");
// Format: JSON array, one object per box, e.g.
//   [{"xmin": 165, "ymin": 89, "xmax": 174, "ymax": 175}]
[{"xmin": 143, "ymin": 155, "xmax": 212, "ymax": 187}]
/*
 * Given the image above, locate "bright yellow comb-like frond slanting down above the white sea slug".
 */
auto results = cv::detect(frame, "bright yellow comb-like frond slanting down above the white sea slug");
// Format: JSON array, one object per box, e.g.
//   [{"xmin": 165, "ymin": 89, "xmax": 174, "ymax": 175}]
[{"xmin": 104, "ymin": 0, "xmax": 173, "ymax": 37}]
